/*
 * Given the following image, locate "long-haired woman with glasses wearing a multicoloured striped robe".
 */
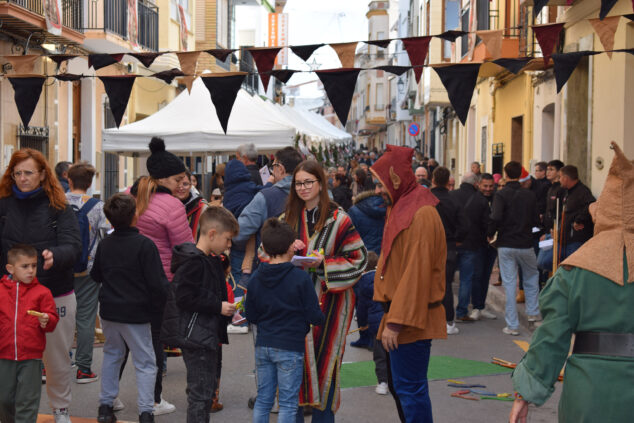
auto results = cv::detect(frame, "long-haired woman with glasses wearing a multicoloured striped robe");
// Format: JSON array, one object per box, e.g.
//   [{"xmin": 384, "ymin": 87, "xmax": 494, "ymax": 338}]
[{"xmin": 285, "ymin": 160, "xmax": 367, "ymax": 422}]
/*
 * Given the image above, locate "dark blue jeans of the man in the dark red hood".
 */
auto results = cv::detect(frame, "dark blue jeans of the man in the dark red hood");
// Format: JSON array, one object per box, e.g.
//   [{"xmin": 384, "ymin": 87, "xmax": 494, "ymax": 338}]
[{"xmin": 390, "ymin": 339, "xmax": 433, "ymax": 423}]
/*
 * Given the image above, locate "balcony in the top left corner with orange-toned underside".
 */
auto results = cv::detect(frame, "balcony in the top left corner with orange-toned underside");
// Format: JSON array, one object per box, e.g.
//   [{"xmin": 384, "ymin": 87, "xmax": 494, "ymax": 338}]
[{"xmin": 0, "ymin": 0, "xmax": 84, "ymax": 44}]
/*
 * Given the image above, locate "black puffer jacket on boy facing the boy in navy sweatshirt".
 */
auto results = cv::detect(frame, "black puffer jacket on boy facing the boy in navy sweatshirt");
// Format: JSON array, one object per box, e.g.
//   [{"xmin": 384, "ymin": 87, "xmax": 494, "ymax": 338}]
[{"xmin": 161, "ymin": 243, "xmax": 231, "ymax": 350}]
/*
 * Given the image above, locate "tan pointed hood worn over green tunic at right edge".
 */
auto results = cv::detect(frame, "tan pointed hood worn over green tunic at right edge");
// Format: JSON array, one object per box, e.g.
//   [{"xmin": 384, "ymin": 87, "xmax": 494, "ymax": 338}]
[{"xmin": 562, "ymin": 141, "xmax": 634, "ymax": 285}]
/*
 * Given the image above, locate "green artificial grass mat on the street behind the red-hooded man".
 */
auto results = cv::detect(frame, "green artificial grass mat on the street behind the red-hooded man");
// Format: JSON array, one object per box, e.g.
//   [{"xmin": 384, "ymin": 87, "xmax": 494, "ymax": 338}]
[{"xmin": 341, "ymin": 355, "xmax": 512, "ymax": 388}]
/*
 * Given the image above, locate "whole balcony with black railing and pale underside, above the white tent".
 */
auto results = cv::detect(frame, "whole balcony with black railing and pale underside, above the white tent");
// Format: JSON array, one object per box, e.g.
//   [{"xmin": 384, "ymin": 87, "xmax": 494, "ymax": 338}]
[{"xmin": 85, "ymin": 0, "xmax": 158, "ymax": 53}]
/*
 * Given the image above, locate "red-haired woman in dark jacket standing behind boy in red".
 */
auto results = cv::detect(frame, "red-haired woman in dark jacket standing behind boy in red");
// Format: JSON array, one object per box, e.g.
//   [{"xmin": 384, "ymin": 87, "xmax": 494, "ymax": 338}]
[{"xmin": 0, "ymin": 148, "xmax": 82, "ymax": 423}]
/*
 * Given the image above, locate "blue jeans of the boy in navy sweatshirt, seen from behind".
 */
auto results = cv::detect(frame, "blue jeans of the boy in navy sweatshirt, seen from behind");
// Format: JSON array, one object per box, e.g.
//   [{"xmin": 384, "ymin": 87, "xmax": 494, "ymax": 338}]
[{"xmin": 253, "ymin": 347, "xmax": 304, "ymax": 423}]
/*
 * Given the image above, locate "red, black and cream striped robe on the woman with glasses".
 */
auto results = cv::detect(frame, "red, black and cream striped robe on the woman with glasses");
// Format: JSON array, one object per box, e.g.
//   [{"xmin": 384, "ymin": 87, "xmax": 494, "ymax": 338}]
[{"xmin": 296, "ymin": 208, "xmax": 367, "ymax": 412}]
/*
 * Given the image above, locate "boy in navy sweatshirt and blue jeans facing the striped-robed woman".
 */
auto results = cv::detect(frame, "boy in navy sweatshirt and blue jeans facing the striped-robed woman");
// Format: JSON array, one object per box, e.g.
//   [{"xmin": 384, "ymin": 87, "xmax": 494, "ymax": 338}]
[{"xmin": 245, "ymin": 218, "xmax": 324, "ymax": 423}]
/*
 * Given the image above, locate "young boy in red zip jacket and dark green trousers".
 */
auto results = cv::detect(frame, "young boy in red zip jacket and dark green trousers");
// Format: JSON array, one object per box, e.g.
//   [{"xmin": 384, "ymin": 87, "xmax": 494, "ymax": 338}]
[{"xmin": 0, "ymin": 245, "xmax": 59, "ymax": 423}]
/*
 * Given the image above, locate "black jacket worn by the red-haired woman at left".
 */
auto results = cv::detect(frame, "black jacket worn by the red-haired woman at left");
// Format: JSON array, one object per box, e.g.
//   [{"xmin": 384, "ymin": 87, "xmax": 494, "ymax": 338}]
[{"xmin": 0, "ymin": 190, "xmax": 82, "ymax": 297}]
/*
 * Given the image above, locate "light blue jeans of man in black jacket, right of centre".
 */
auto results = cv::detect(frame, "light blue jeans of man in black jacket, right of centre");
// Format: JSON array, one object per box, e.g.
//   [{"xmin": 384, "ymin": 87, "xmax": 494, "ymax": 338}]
[{"xmin": 498, "ymin": 247, "xmax": 539, "ymax": 329}]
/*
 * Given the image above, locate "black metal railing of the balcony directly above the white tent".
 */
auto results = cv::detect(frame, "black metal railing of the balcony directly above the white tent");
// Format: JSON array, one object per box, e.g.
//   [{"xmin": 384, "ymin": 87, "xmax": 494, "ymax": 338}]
[{"xmin": 85, "ymin": 0, "xmax": 158, "ymax": 50}]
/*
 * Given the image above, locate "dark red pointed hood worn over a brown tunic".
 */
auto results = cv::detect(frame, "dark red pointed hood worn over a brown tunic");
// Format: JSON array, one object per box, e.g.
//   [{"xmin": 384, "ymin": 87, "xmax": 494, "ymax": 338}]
[{"xmin": 370, "ymin": 144, "xmax": 438, "ymax": 263}]
